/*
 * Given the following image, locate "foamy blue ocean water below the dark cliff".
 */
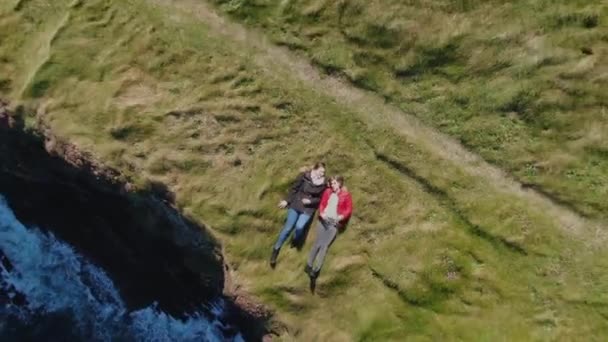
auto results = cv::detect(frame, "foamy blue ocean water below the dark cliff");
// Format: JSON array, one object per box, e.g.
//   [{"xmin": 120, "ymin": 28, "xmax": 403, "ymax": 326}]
[{"xmin": 0, "ymin": 195, "xmax": 243, "ymax": 341}]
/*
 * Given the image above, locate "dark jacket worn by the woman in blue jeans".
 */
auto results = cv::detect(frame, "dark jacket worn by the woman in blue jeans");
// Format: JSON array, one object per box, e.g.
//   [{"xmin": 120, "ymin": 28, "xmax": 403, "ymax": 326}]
[{"xmin": 286, "ymin": 171, "xmax": 327, "ymax": 216}]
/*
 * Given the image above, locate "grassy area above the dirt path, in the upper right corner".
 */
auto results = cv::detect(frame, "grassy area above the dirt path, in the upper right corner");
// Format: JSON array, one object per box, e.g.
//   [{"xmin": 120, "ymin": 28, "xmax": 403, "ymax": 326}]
[{"xmin": 215, "ymin": 0, "xmax": 608, "ymax": 218}]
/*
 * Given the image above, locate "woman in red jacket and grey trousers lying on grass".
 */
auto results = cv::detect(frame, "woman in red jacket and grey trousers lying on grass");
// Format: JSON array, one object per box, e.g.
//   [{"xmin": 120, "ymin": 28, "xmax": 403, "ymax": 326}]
[{"xmin": 304, "ymin": 176, "xmax": 353, "ymax": 282}]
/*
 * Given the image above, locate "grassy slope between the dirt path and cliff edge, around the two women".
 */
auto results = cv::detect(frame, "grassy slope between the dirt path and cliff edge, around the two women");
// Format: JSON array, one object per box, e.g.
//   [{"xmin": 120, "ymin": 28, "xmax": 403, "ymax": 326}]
[{"xmin": 0, "ymin": 0, "xmax": 608, "ymax": 340}]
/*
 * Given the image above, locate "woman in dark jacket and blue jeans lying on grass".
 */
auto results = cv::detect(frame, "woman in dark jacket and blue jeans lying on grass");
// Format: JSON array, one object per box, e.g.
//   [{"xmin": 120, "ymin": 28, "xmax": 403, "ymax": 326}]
[{"xmin": 270, "ymin": 163, "xmax": 326, "ymax": 268}]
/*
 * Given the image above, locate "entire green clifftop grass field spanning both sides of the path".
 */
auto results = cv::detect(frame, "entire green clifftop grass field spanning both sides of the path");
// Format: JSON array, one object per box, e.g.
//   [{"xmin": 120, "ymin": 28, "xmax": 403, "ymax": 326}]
[{"xmin": 0, "ymin": 0, "xmax": 608, "ymax": 341}]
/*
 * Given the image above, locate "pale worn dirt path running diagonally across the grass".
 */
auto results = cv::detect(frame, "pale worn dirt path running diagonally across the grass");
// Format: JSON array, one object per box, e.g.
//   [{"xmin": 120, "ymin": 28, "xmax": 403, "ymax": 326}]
[{"xmin": 151, "ymin": 0, "xmax": 605, "ymax": 236}]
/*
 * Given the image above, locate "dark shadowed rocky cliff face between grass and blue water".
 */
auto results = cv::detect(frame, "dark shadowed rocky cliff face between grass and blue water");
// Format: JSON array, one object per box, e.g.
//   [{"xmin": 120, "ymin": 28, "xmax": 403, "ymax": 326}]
[{"xmin": 0, "ymin": 103, "xmax": 265, "ymax": 339}]
